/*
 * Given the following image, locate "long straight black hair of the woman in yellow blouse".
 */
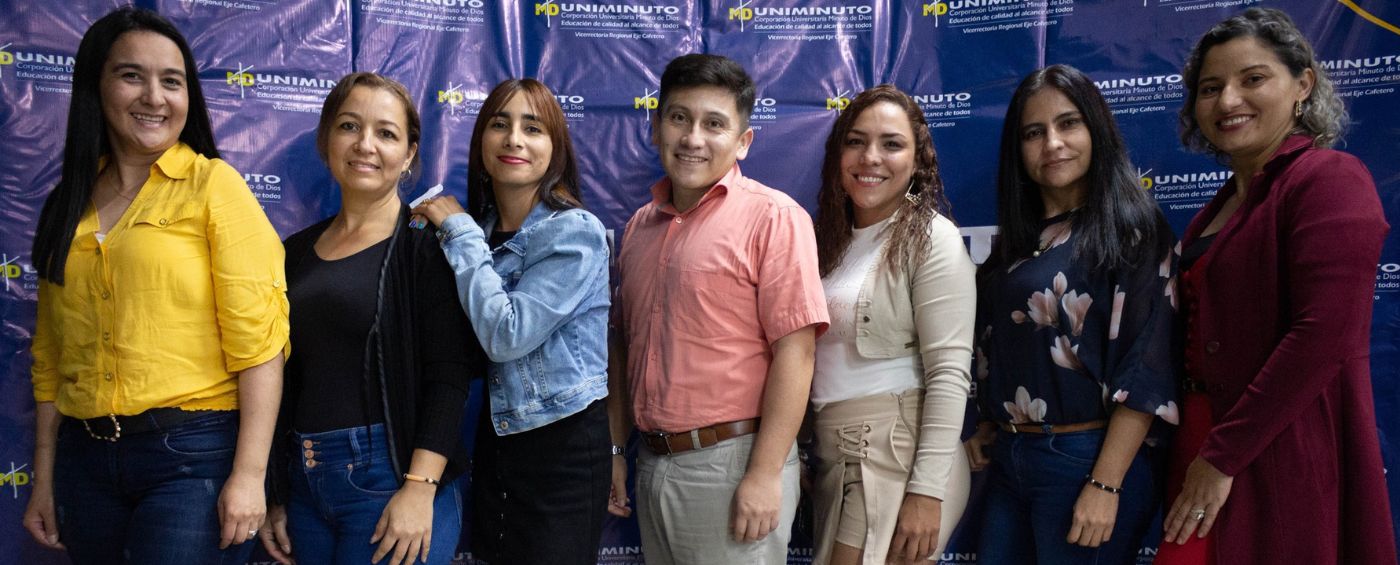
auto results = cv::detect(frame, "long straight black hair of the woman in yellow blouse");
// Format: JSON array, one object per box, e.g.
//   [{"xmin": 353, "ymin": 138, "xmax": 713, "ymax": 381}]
[{"xmin": 32, "ymin": 6, "xmax": 218, "ymax": 285}]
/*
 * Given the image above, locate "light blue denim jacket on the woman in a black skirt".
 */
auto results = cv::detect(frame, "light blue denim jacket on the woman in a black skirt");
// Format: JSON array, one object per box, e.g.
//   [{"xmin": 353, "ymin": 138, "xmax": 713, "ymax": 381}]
[{"xmin": 438, "ymin": 204, "xmax": 609, "ymax": 435}]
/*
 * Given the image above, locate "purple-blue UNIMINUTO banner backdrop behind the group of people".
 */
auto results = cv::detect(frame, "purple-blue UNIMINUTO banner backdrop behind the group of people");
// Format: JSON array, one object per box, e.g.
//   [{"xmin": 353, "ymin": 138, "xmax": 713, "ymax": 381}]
[{"xmin": 0, "ymin": 0, "xmax": 1400, "ymax": 565}]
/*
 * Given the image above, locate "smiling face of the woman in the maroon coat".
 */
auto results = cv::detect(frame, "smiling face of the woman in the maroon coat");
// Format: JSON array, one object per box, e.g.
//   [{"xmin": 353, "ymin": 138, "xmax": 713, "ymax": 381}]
[{"xmin": 1196, "ymin": 36, "xmax": 1313, "ymax": 171}]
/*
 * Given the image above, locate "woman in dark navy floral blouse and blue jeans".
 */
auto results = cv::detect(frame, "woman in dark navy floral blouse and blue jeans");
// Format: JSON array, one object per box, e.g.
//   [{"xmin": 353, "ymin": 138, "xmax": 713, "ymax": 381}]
[{"xmin": 967, "ymin": 64, "xmax": 1177, "ymax": 565}]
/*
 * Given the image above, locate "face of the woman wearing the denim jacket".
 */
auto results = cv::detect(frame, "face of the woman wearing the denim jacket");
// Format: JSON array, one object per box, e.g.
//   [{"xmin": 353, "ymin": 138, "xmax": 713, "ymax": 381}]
[{"xmin": 482, "ymin": 92, "xmax": 554, "ymax": 194}]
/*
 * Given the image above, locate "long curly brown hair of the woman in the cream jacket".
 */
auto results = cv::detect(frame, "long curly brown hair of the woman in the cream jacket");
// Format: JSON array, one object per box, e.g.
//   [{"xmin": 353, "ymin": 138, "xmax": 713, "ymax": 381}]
[{"xmin": 815, "ymin": 84, "xmax": 952, "ymax": 277}]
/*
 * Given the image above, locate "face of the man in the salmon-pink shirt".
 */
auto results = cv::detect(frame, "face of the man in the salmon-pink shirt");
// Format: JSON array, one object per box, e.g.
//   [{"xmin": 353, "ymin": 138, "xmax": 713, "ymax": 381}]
[{"xmin": 651, "ymin": 87, "xmax": 753, "ymax": 201}]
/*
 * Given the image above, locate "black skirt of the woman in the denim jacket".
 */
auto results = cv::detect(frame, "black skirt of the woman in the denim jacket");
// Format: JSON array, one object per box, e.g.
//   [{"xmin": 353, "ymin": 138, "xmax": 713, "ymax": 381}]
[{"xmin": 472, "ymin": 400, "xmax": 612, "ymax": 565}]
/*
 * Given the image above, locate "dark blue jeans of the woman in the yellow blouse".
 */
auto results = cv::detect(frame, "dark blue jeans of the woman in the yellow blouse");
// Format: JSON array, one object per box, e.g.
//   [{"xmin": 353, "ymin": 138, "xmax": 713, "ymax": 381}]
[{"xmin": 53, "ymin": 411, "xmax": 253, "ymax": 565}]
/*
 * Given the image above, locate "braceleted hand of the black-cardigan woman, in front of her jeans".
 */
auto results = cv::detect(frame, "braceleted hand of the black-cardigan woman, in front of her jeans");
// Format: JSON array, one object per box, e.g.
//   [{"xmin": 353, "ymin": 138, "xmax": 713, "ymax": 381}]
[{"xmin": 370, "ymin": 481, "xmax": 437, "ymax": 565}]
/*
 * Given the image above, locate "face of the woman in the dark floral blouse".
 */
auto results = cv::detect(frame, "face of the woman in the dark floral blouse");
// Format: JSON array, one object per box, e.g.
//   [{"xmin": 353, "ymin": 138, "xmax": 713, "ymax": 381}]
[{"xmin": 1021, "ymin": 87, "xmax": 1093, "ymax": 201}]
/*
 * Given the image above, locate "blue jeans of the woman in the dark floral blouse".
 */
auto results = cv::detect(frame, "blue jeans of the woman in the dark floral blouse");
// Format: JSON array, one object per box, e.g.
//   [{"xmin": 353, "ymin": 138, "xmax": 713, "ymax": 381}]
[{"xmin": 977, "ymin": 429, "xmax": 1161, "ymax": 565}]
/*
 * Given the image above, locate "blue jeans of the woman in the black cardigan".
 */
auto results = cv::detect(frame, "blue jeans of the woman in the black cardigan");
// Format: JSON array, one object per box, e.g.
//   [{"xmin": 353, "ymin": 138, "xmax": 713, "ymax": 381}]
[{"xmin": 281, "ymin": 424, "xmax": 462, "ymax": 565}]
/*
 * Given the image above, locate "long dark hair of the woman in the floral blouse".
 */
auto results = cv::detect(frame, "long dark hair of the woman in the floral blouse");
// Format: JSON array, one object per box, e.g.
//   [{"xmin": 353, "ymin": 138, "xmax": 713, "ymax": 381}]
[{"xmin": 981, "ymin": 64, "xmax": 1172, "ymax": 274}]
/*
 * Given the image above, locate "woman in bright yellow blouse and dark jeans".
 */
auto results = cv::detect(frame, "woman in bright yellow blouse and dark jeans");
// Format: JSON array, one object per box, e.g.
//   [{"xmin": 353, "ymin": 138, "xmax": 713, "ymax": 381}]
[{"xmin": 24, "ymin": 7, "xmax": 287, "ymax": 564}]
